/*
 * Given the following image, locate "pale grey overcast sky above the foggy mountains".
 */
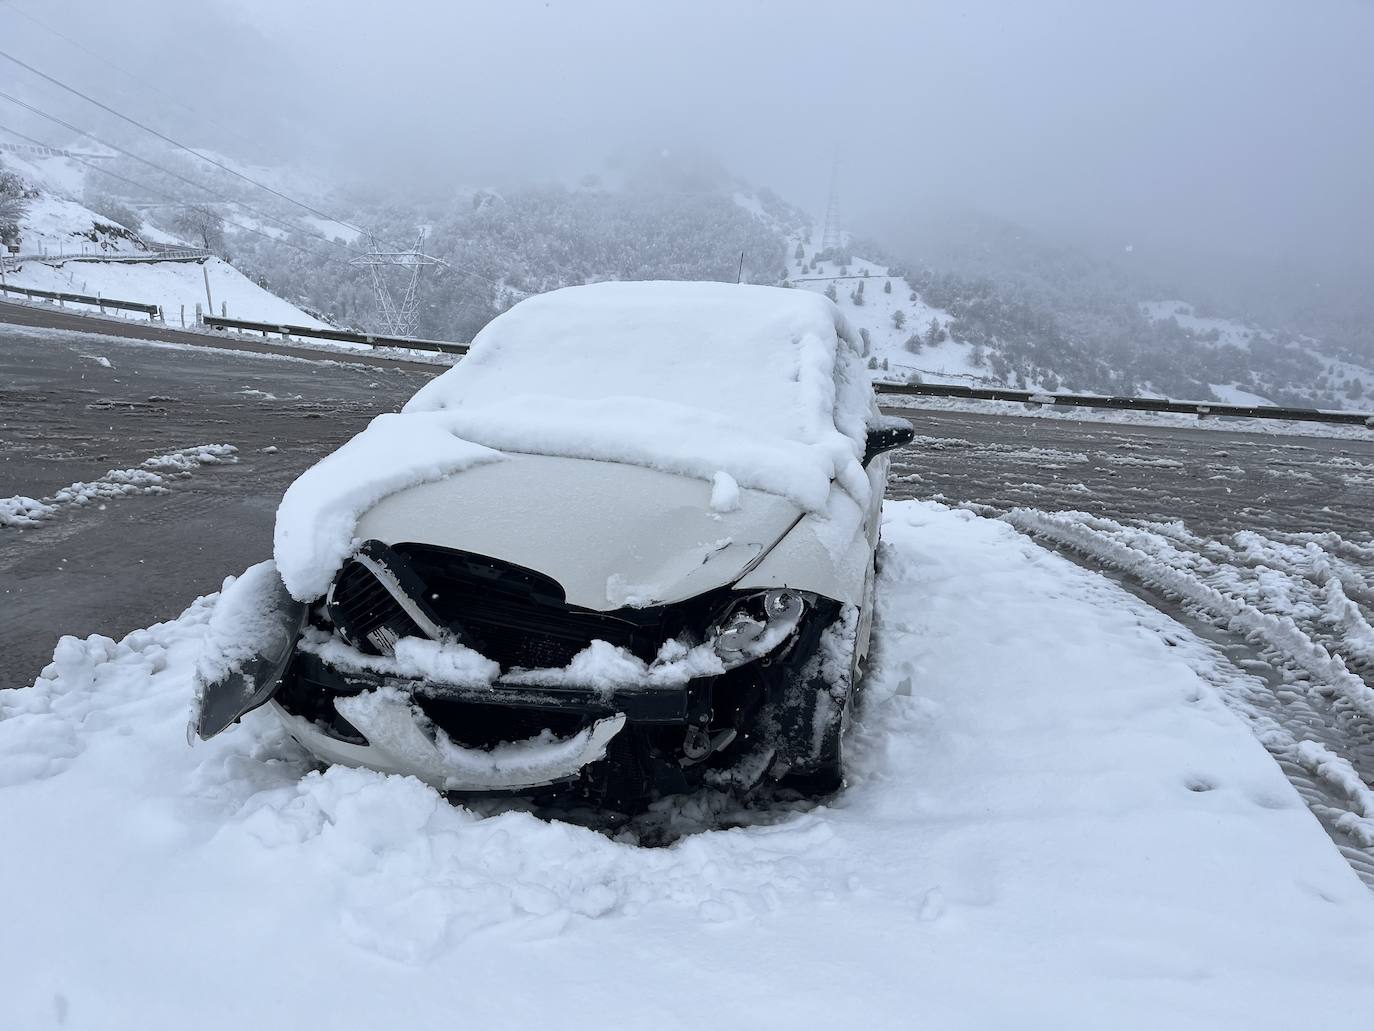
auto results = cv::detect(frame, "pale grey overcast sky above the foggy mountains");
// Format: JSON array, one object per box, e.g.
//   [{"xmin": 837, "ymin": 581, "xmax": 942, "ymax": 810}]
[{"xmin": 0, "ymin": 0, "xmax": 1374, "ymax": 283}]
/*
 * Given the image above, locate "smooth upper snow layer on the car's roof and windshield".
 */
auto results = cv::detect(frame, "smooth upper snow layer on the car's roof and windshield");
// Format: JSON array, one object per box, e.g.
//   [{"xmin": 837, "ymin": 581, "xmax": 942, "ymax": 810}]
[{"xmin": 405, "ymin": 282, "xmax": 861, "ymax": 443}]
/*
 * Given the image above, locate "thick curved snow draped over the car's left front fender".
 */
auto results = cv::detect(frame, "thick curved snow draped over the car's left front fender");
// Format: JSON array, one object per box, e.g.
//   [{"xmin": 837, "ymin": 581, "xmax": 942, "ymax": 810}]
[{"xmin": 272, "ymin": 412, "xmax": 502, "ymax": 601}]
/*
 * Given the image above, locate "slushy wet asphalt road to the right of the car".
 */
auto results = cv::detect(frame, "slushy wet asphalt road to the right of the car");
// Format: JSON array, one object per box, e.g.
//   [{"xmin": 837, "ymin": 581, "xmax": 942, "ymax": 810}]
[{"xmin": 889, "ymin": 408, "xmax": 1374, "ymax": 540}]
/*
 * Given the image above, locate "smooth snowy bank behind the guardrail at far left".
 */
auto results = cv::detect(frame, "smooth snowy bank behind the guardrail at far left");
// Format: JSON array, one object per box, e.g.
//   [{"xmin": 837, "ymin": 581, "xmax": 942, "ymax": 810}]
[{"xmin": 5, "ymin": 257, "xmax": 324, "ymax": 327}]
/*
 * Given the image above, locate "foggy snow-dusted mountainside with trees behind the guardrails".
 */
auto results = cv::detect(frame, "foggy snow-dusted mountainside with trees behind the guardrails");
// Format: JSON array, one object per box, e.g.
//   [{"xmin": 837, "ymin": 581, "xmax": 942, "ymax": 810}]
[{"xmin": 4, "ymin": 135, "xmax": 1374, "ymax": 407}]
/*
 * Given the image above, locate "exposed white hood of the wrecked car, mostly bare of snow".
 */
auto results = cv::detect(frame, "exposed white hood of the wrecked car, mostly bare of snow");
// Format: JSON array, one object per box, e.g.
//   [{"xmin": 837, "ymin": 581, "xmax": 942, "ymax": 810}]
[{"xmin": 357, "ymin": 454, "xmax": 802, "ymax": 612}]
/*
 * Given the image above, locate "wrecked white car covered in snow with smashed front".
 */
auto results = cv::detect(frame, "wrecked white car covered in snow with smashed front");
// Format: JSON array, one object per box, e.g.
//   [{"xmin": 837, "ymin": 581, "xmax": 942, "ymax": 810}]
[{"xmin": 192, "ymin": 283, "xmax": 911, "ymax": 808}]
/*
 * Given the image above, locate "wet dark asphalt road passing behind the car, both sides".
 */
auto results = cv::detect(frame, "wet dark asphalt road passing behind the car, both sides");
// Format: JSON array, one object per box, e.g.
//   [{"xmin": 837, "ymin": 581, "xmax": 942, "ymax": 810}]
[{"xmin": 0, "ymin": 326, "xmax": 1374, "ymax": 686}]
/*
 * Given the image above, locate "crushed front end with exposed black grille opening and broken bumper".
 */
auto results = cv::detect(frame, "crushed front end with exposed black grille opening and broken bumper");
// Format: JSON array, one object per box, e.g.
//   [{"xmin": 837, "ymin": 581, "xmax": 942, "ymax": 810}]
[{"xmin": 237, "ymin": 540, "xmax": 856, "ymax": 808}]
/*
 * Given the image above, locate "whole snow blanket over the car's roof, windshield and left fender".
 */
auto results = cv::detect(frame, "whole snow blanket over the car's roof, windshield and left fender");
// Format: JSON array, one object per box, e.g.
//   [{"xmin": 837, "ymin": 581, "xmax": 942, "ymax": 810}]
[{"xmin": 275, "ymin": 282, "xmax": 872, "ymax": 601}]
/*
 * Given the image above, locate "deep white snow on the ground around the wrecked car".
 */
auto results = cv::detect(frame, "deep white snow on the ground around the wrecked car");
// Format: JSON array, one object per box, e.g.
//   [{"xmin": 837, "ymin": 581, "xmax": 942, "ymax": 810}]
[{"xmin": 0, "ymin": 503, "xmax": 1374, "ymax": 1031}]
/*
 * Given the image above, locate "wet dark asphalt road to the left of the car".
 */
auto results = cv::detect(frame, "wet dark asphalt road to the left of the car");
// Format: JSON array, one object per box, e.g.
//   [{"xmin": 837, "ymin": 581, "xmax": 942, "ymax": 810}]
[{"xmin": 0, "ymin": 326, "xmax": 431, "ymax": 687}]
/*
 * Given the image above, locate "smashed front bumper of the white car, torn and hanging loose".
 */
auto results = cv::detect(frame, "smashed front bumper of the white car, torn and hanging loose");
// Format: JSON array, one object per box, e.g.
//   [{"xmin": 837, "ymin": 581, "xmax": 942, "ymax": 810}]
[{"xmin": 192, "ymin": 552, "xmax": 846, "ymax": 807}]
